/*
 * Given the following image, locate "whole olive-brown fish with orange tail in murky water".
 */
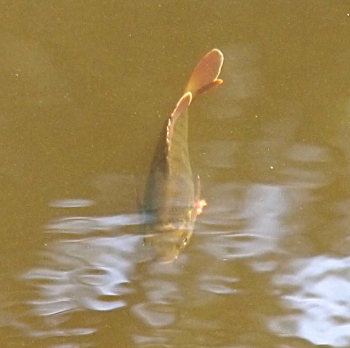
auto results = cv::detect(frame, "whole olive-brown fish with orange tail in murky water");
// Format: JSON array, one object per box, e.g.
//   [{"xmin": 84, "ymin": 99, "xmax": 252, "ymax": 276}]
[{"xmin": 143, "ymin": 49, "xmax": 223, "ymax": 262}]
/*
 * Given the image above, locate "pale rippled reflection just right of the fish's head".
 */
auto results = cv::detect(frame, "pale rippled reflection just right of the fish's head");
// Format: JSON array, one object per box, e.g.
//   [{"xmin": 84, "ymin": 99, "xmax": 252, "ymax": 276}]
[{"xmin": 202, "ymin": 184, "xmax": 288, "ymax": 260}]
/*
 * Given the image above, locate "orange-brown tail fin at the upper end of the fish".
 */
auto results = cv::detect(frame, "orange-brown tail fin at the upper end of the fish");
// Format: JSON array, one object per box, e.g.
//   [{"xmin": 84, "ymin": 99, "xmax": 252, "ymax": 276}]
[{"xmin": 186, "ymin": 48, "xmax": 224, "ymax": 97}]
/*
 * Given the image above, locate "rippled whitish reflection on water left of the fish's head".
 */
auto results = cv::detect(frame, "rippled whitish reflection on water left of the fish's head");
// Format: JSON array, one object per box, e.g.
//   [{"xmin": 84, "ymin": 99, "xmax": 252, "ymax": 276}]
[{"xmin": 22, "ymin": 215, "xmax": 145, "ymax": 336}]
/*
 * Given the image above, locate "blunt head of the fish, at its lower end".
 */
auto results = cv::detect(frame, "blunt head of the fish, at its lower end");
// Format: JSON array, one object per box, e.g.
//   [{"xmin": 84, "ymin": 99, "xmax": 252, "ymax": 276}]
[{"xmin": 144, "ymin": 223, "xmax": 193, "ymax": 263}]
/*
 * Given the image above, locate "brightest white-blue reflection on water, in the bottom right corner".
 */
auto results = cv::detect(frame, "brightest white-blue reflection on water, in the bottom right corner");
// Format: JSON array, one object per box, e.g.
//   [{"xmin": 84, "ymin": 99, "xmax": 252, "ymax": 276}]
[{"xmin": 270, "ymin": 256, "xmax": 350, "ymax": 347}]
